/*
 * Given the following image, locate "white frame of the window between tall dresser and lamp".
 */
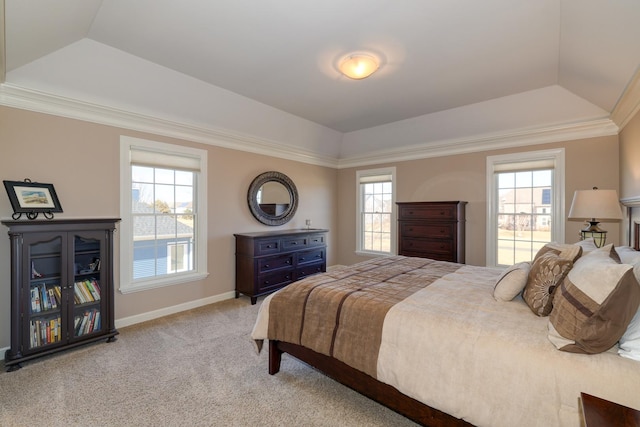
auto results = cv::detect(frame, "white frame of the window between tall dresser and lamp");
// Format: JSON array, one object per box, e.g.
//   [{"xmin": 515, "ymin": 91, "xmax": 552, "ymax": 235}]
[{"xmin": 486, "ymin": 148, "xmax": 566, "ymax": 267}]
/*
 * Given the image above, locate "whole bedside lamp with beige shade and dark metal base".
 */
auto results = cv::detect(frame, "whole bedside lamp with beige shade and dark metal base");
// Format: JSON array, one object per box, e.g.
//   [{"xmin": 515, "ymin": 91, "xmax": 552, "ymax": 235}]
[{"xmin": 569, "ymin": 187, "xmax": 622, "ymax": 248}]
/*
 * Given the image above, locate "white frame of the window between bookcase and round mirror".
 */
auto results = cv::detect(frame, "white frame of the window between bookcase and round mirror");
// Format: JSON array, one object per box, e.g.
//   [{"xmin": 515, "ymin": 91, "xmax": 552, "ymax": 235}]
[{"xmin": 119, "ymin": 135, "xmax": 209, "ymax": 294}]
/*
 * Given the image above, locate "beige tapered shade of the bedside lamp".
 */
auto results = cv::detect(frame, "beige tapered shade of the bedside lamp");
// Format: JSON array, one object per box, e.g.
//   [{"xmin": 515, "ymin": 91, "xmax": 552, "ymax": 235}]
[{"xmin": 569, "ymin": 188, "xmax": 622, "ymax": 221}]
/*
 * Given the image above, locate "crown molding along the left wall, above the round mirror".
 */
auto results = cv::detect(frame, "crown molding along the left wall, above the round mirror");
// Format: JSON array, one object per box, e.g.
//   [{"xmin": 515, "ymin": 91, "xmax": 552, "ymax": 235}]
[{"xmin": 0, "ymin": 83, "xmax": 338, "ymax": 168}]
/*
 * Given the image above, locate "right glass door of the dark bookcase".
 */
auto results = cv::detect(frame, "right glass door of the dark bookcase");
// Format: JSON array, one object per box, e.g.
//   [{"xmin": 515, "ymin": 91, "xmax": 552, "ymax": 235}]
[{"xmin": 69, "ymin": 231, "xmax": 105, "ymax": 339}]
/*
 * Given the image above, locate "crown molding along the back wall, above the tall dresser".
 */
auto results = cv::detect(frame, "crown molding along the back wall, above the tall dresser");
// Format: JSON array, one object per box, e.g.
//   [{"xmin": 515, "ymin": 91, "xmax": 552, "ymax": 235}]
[{"xmin": 338, "ymin": 119, "xmax": 619, "ymax": 169}]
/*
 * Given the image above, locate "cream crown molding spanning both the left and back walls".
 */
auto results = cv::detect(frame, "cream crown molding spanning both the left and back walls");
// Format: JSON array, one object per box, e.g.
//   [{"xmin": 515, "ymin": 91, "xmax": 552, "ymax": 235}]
[{"xmin": 0, "ymin": 83, "xmax": 624, "ymax": 169}]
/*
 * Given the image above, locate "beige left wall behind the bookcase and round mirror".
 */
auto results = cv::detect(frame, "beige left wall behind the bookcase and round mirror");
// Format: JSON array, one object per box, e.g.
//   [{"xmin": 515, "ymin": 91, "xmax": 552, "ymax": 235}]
[{"xmin": 0, "ymin": 107, "xmax": 337, "ymax": 348}]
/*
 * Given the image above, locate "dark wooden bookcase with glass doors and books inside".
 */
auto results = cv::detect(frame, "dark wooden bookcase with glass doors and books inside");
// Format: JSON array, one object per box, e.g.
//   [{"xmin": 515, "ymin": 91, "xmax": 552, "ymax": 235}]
[{"xmin": 2, "ymin": 219, "xmax": 119, "ymax": 371}]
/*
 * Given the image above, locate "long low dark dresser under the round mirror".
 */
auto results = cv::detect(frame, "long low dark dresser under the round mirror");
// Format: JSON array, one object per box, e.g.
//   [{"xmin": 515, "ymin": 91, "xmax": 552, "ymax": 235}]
[{"xmin": 234, "ymin": 229, "xmax": 329, "ymax": 304}]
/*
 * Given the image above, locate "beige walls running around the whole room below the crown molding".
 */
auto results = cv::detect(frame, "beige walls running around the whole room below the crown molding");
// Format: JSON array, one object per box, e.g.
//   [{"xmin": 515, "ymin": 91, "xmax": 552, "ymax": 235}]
[{"xmin": 0, "ymin": 103, "xmax": 640, "ymax": 348}]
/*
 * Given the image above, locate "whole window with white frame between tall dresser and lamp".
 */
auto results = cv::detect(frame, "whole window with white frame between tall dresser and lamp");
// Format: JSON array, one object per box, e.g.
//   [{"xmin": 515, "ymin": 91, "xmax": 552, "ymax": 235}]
[{"xmin": 487, "ymin": 149, "xmax": 564, "ymax": 266}]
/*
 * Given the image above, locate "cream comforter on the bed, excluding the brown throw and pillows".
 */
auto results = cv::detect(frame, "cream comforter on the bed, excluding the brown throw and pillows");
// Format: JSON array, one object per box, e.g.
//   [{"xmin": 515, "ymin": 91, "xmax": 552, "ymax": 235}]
[{"xmin": 252, "ymin": 266, "xmax": 640, "ymax": 427}]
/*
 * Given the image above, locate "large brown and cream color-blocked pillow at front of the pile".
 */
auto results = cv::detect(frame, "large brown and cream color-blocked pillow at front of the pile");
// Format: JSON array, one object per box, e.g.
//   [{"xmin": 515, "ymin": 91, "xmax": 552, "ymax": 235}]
[{"xmin": 549, "ymin": 246, "xmax": 640, "ymax": 354}]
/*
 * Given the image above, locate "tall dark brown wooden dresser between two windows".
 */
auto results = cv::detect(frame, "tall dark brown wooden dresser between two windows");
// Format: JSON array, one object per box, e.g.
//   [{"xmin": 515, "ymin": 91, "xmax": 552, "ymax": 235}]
[{"xmin": 397, "ymin": 201, "xmax": 467, "ymax": 264}]
